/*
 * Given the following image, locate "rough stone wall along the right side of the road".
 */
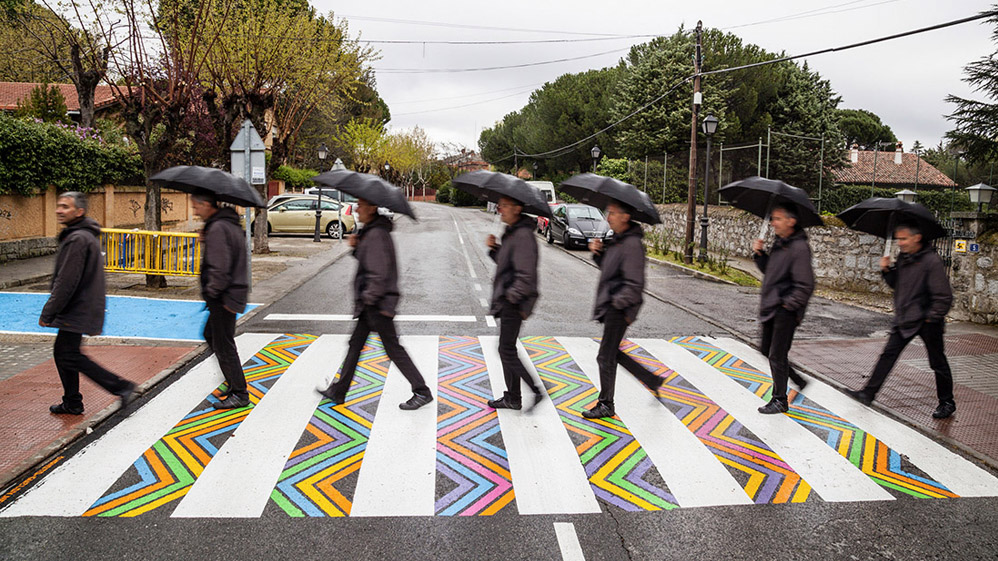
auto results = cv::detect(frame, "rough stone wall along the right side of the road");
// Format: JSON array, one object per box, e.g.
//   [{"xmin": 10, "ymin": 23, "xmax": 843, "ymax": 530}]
[{"xmin": 656, "ymin": 204, "xmax": 998, "ymax": 323}]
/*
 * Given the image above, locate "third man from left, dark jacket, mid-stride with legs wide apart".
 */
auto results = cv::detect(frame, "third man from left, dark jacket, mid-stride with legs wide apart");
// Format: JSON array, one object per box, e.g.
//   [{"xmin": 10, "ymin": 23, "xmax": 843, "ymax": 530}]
[{"xmin": 319, "ymin": 199, "xmax": 433, "ymax": 411}]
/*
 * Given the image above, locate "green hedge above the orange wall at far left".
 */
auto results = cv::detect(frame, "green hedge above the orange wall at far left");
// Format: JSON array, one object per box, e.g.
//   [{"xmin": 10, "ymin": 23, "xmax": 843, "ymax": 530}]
[{"xmin": 0, "ymin": 114, "xmax": 142, "ymax": 195}]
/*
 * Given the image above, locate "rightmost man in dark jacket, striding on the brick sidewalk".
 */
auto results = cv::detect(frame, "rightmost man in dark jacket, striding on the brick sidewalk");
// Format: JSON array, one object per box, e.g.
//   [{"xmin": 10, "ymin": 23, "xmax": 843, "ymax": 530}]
[{"xmin": 846, "ymin": 224, "xmax": 956, "ymax": 419}]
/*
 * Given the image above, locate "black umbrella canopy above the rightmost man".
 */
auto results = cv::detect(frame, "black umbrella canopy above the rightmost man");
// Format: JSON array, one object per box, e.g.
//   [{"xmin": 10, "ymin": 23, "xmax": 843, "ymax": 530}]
[{"xmin": 838, "ymin": 197, "xmax": 946, "ymax": 241}]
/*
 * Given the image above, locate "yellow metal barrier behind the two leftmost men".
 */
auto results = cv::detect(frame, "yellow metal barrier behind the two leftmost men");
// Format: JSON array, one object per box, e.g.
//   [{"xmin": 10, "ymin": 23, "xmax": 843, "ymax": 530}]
[{"xmin": 101, "ymin": 228, "xmax": 201, "ymax": 277}]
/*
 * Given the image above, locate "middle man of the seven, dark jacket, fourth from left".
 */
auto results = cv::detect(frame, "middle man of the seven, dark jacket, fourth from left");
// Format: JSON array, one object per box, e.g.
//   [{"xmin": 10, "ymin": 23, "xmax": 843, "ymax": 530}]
[{"xmin": 485, "ymin": 197, "xmax": 544, "ymax": 409}]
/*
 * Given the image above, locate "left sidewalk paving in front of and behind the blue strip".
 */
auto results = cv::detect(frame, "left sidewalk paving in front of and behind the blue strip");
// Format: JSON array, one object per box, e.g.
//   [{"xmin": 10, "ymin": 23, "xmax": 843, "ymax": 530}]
[{"xmin": 0, "ymin": 236, "xmax": 350, "ymax": 490}]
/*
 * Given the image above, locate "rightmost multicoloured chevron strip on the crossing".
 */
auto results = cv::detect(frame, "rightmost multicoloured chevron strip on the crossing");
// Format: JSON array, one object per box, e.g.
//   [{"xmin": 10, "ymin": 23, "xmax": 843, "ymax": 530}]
[{"xmin": 672, "ymin": 337, "xmax": 957, "ymax": 498}]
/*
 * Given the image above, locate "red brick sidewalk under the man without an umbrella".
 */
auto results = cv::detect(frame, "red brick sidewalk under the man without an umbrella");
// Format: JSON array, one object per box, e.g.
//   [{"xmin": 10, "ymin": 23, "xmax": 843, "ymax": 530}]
[{"xmin": 0, "ymin": 343, "xmax": 197, "ymax": 487}]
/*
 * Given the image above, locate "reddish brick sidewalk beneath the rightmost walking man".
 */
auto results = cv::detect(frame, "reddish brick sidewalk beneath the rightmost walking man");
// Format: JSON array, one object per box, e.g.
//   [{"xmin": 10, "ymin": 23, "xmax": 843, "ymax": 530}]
[{"xmin": 790, "ymin": 327, "xmax": 998, "ymax": 467}]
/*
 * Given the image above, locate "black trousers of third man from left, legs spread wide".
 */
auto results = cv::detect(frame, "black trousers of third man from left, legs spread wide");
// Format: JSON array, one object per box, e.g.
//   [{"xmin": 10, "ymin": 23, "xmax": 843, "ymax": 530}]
[{"xmin": 330, "ymin": 306, "xmax": 431, "ymax": 396}]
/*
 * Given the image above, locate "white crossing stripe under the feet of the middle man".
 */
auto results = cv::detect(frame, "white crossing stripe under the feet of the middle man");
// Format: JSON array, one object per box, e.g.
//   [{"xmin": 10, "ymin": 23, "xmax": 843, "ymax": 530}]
[{"xmin": 478, "ymin": 335, "xmax": 600, "ymax": 514}]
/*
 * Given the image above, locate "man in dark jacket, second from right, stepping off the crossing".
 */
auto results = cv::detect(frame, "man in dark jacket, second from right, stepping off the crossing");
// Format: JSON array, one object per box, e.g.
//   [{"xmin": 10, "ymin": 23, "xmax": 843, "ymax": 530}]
[{"xmin": 752, "ymin": 205, "xmax": 814, "ymax": 415}]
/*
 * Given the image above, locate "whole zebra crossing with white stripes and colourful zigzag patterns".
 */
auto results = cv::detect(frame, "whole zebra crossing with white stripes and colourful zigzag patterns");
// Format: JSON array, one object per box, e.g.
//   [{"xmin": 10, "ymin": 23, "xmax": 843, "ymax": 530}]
[{"xmin": 0, "ymin": 334, "xmax": 998, "ymax": 517}]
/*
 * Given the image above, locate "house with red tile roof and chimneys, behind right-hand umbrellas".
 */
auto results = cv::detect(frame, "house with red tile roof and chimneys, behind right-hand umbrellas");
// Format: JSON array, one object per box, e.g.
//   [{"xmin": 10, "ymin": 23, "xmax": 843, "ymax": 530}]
[{"xmin": 832, "ymin": 142, "xmax": 956, "ymax": 189}]
